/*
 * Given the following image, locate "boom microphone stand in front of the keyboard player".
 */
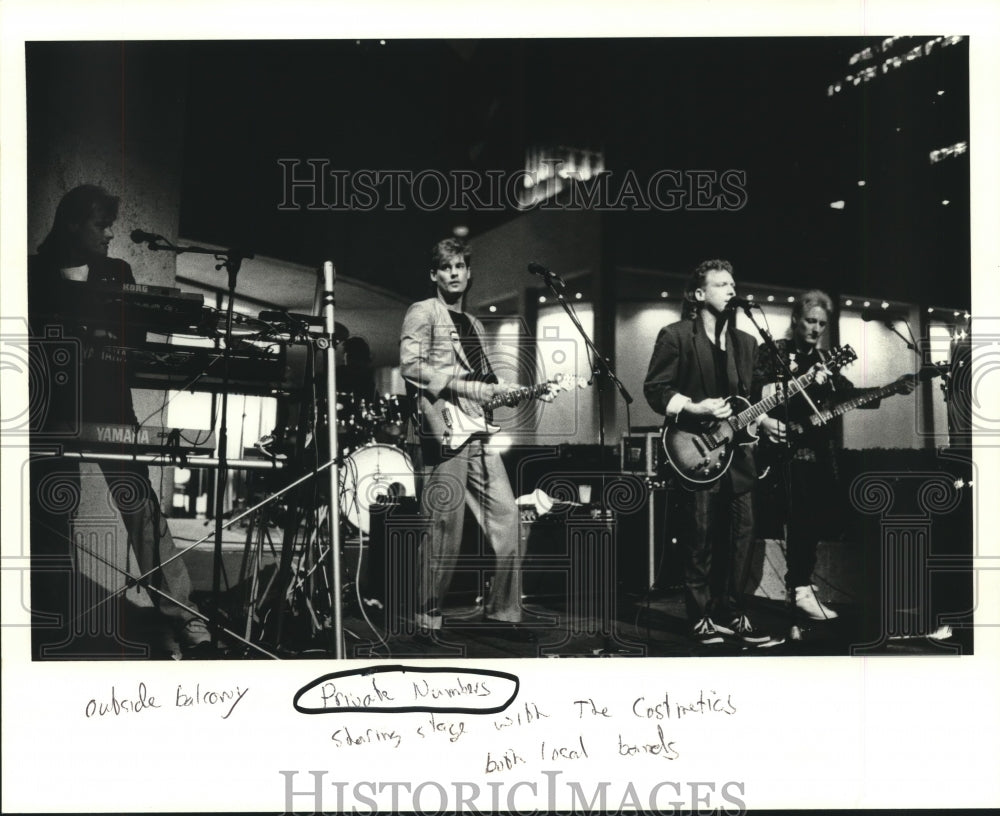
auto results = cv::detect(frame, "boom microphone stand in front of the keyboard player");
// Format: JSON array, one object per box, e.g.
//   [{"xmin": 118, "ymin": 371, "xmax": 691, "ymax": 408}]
[{"xmin": 139, "ymin": 236, "xmax": 254, "ymax": 646}]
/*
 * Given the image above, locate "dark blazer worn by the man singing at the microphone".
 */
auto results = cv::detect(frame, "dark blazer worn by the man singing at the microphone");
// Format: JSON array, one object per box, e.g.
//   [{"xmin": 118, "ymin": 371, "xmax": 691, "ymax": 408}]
[{"xmin": 643, "ymin": 319, "xmax": 757, "ymax": 493}]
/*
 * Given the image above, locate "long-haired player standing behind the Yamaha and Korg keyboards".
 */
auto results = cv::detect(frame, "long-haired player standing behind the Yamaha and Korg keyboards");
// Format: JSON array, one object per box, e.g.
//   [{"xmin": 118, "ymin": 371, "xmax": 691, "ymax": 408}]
[{"xmin": 28, "ymin": 184, "xmax": 212, "ymax": 658}]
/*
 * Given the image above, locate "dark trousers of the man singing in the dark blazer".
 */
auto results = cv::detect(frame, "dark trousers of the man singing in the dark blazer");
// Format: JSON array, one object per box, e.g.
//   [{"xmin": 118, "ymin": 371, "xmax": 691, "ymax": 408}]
[{"xmin": 680, "ymin": 480, "xmax": 753, "ymax": 624}]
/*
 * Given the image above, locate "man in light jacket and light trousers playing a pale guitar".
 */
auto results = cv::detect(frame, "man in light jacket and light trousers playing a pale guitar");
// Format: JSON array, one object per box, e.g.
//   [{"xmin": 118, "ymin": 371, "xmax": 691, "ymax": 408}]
[{"xmin": 399, "ymin": 238, "xmax": 552, "ymax": 640}]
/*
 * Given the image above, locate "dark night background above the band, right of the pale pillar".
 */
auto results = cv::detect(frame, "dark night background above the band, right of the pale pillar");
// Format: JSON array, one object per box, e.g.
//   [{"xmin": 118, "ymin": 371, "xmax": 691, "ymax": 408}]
[{"xmin": 162, "ymin": 36, "xmax": 970, "ymax": 307}]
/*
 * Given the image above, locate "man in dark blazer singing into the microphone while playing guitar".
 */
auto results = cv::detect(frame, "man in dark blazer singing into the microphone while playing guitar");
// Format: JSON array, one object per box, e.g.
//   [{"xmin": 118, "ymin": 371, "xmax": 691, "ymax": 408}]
[{"xmin": 643, "ymin": 260, "xmax": 769, "ymax": 645}]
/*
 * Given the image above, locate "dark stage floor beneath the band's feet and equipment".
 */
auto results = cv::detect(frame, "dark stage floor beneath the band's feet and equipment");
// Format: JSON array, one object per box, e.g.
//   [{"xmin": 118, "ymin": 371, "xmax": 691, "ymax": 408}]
[{"xmin": 34, "ymin": 519, "xmax": 973, "ymax": 660}]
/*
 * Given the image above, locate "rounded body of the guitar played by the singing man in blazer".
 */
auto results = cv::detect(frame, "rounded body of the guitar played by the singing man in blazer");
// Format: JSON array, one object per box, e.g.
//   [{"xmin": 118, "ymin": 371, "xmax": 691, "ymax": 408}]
[{"xmin": 663, "ymin": 397, "xmax": 753, "ymax": 487}]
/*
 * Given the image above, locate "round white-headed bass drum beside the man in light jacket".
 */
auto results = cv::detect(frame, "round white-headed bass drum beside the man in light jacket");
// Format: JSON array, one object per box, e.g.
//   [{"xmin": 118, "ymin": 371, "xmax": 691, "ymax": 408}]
[{"xmin": 340, "ymin": 445, "xmax": 417, "ymax": 534}]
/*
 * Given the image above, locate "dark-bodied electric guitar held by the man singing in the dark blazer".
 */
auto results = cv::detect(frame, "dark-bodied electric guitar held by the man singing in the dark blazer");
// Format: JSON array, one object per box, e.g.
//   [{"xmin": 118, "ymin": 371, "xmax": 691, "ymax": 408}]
[{"xmin": 662, "ymin": 346, "xmax": 858, "ymax": 485}]
